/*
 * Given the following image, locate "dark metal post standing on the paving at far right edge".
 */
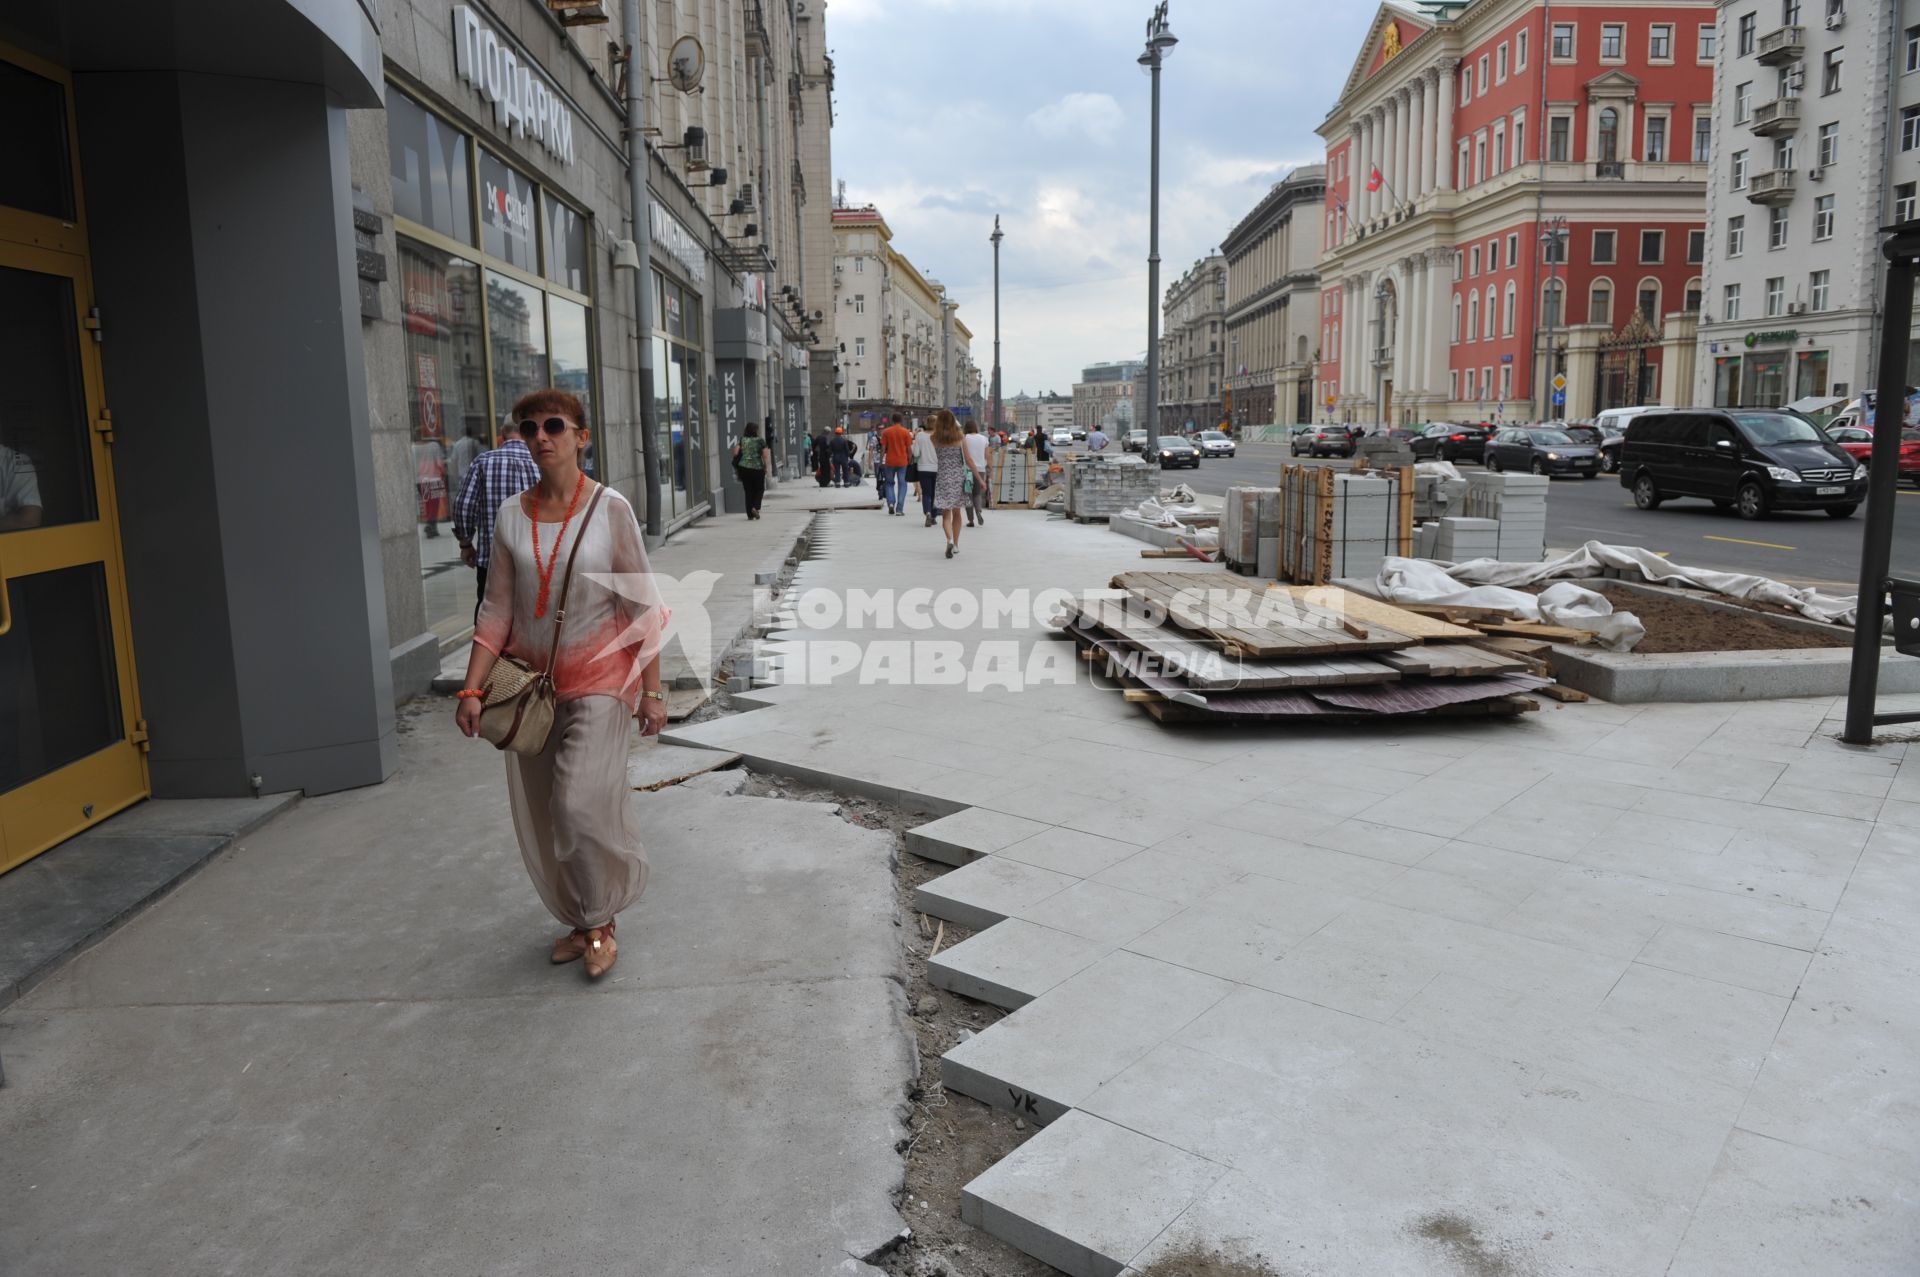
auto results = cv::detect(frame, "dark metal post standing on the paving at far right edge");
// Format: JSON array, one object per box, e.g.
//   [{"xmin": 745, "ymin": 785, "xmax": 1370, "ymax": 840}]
[{"xmin": 1839, "ymin": 234, "xmax": 1920, "ymax": 745}]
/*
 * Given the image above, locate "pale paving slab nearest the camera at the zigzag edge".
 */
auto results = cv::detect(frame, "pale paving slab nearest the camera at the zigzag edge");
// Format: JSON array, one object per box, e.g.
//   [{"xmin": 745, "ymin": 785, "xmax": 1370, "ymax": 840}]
[{"xmin": 960, "ymin": 1114, "xmax": 1227, "ymax": 1277}]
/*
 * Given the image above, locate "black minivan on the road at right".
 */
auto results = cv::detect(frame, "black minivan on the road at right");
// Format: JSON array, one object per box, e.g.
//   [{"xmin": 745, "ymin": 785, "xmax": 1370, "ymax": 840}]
[{"xmin": 1620, "ymin": 407, "xmax": 1866, "ymax": 518}]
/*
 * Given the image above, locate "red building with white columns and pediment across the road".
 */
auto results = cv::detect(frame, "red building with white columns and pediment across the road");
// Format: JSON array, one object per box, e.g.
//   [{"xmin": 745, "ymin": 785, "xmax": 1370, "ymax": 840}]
[{"xmin": 1317, "ymin": 0, "xmax": 1715, "ymax": 424}]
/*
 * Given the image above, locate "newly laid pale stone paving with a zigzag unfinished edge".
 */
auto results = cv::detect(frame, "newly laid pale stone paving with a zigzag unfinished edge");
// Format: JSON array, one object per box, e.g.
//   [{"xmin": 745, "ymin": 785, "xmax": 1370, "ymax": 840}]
[{"xmin": 668, "ymin": 511, "xmax": 1920, "ymax": 1277}]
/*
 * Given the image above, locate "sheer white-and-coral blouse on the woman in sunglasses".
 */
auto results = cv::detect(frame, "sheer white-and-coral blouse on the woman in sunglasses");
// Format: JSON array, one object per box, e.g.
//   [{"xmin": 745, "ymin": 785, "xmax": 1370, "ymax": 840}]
[{"xmin": 474, "ymin": 488, "xmax": 668, "ymax": 709}]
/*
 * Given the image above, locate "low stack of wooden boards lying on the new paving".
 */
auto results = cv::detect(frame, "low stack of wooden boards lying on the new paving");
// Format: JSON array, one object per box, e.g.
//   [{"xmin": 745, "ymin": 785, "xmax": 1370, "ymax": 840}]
[{"xmin": 1062, "ymin": 570, "xmax": 1549, "ymax": 722}]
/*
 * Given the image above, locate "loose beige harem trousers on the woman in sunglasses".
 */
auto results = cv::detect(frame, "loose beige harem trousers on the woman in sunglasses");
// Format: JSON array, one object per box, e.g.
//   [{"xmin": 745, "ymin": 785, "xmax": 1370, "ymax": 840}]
[{"xmin": 507, "ymin": 697, "xmax": 647, "ymax": 929}]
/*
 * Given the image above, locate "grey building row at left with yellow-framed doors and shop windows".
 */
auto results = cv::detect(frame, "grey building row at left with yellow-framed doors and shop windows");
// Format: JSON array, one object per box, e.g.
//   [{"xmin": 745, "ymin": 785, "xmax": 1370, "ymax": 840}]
[{"xmin": 0, "ymin": 0, "xmax": 831, "ymax": 870}]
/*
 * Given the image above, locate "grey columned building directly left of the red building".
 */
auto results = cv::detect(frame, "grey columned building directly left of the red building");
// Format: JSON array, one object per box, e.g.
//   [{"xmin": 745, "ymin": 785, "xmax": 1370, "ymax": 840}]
[{"xmin": 1221, "ymin": 163, "xmax": 1327, "ymax": 432}]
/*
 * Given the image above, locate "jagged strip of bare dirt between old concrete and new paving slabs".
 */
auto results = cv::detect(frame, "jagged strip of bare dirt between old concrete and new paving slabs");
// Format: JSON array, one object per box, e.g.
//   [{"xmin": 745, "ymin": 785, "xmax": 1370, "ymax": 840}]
[{"xmin": 741, "ymin": 772, "xmax": 1059, "ymax": 1277}]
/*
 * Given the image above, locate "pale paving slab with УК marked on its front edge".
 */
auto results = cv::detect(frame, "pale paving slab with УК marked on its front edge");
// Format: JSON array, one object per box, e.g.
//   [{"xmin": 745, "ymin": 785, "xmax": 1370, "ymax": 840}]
[{"xmin": 941, "ymin": 952, "xmax": 1233, "ymax": 1123}]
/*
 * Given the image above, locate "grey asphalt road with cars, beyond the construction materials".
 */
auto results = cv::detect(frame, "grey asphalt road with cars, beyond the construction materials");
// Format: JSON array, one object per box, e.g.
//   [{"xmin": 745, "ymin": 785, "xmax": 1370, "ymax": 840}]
[{"xmin": 1067, "ymin": 444, "xmax": 1920, "ymax": 593}]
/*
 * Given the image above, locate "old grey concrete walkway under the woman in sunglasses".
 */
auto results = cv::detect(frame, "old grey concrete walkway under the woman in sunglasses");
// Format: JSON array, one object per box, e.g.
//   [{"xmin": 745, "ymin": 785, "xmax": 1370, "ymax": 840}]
[{"xmin": 0, "ymin": 702, "xmax": 914, "ymax": 1277}]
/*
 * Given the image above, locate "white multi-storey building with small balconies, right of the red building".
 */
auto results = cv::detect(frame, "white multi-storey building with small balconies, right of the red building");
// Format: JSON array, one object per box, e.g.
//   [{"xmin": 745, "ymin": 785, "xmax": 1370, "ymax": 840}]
[{"xmin": 1693, "ymin": 0, "xmax": 1920, "ymax": 407}]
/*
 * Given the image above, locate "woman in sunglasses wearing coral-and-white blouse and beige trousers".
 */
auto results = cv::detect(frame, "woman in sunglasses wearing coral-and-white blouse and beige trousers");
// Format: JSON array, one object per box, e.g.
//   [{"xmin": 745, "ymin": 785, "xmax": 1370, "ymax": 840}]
[{"xmin": 455, "ymin": 388, "xmax": 668, "ymax": 979}]
